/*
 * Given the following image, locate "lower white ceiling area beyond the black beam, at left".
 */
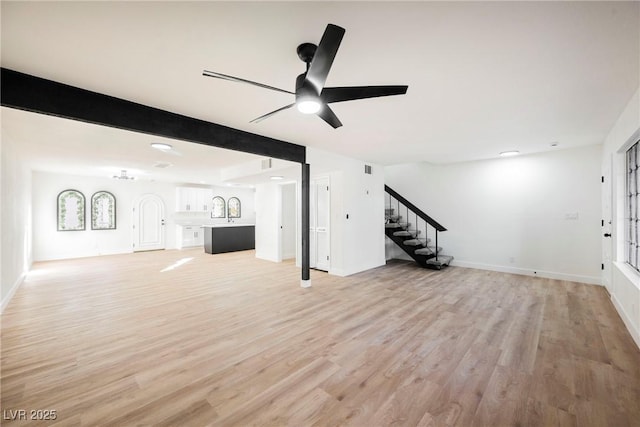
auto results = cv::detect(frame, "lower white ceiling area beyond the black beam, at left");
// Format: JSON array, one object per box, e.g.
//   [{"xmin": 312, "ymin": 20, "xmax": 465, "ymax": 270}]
[{"xmin": 1, "ymin": 107, "xmax": 300, "ymax": 186}]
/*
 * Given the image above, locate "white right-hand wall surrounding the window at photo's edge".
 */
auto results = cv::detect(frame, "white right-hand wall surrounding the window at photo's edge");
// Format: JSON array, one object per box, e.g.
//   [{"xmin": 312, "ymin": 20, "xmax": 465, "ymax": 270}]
[{"xmin": 602, "ymin": 89, "xmax": 640, "ymax": 347}]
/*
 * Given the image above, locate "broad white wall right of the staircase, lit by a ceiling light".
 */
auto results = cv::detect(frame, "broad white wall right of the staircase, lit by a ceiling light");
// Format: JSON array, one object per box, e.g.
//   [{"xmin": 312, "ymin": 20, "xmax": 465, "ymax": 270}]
[{"xmin": 385, "ymin": 145, "xmax": 602, "ymax": 283}]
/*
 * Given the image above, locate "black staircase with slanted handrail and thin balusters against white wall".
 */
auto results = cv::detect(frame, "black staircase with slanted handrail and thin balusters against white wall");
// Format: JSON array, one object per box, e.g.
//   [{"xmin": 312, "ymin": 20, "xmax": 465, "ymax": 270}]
[{"xmin": 384, "ymin": 185, "xmax": 453, "ymax": 270}]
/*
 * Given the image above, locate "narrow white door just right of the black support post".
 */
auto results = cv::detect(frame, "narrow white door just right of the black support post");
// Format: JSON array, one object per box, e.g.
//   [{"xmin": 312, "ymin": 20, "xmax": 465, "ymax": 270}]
[{"xmin": 309, "ymin": 176, "xmax": 330, "ymax": 271}]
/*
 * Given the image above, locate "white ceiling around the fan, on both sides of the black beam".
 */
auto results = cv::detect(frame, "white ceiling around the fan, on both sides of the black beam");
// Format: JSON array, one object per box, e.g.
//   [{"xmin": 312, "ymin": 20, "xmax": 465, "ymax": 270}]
[{"xmin": 1, "ymin": 1, "xmax": 640, "ymax": 181}]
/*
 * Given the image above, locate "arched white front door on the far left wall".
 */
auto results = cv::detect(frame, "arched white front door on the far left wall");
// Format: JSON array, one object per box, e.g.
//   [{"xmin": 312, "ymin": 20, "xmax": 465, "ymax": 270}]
[{"xmin": 133, "ymin": 194, "xmax": 164, "ymax": 252}]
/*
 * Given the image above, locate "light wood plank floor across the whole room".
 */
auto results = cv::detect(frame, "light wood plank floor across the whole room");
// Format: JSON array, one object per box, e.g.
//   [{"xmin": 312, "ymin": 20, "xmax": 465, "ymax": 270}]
[{"xmin": 1, "ymin": 250, "xmax": 640, "ymax": 427}]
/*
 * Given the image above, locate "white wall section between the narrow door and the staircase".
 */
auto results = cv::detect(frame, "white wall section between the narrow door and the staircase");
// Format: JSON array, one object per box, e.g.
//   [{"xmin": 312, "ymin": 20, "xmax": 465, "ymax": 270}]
[{"xmin": 307, "ymin": 147, "xmax": 385, "ymax": 276}]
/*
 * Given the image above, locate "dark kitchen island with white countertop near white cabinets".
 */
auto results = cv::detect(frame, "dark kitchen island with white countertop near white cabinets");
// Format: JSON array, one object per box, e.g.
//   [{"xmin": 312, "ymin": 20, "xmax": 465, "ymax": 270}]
[{"xmin": 203, "ymin": 224, "xmax": 256, "ymax": 254}]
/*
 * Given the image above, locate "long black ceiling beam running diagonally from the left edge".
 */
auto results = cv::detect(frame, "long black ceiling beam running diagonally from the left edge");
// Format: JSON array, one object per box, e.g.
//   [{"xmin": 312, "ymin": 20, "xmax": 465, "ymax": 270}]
[{"xmin": 0, "ymin": 68, "xmax": 306, "ymax": 163}]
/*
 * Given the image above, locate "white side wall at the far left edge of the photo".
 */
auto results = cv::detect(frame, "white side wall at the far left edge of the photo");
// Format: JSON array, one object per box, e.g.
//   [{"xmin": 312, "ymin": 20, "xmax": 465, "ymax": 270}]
[{"xmin": 0, "ymin": 133, "xmax": 32, "ymax": 311}]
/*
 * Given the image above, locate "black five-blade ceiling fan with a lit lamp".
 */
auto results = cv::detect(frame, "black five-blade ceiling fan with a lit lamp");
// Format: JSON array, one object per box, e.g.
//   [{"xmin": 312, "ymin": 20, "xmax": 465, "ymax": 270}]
[{"xmin": 202, "ymin": 24, "xmax": 408, "ymax": 129}]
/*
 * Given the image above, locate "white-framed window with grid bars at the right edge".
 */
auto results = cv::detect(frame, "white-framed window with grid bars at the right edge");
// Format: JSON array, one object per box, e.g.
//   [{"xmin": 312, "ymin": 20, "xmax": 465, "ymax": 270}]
[{"xmin": 625, "ymin": 141, "xmax": 640, "ymax": 271}]
